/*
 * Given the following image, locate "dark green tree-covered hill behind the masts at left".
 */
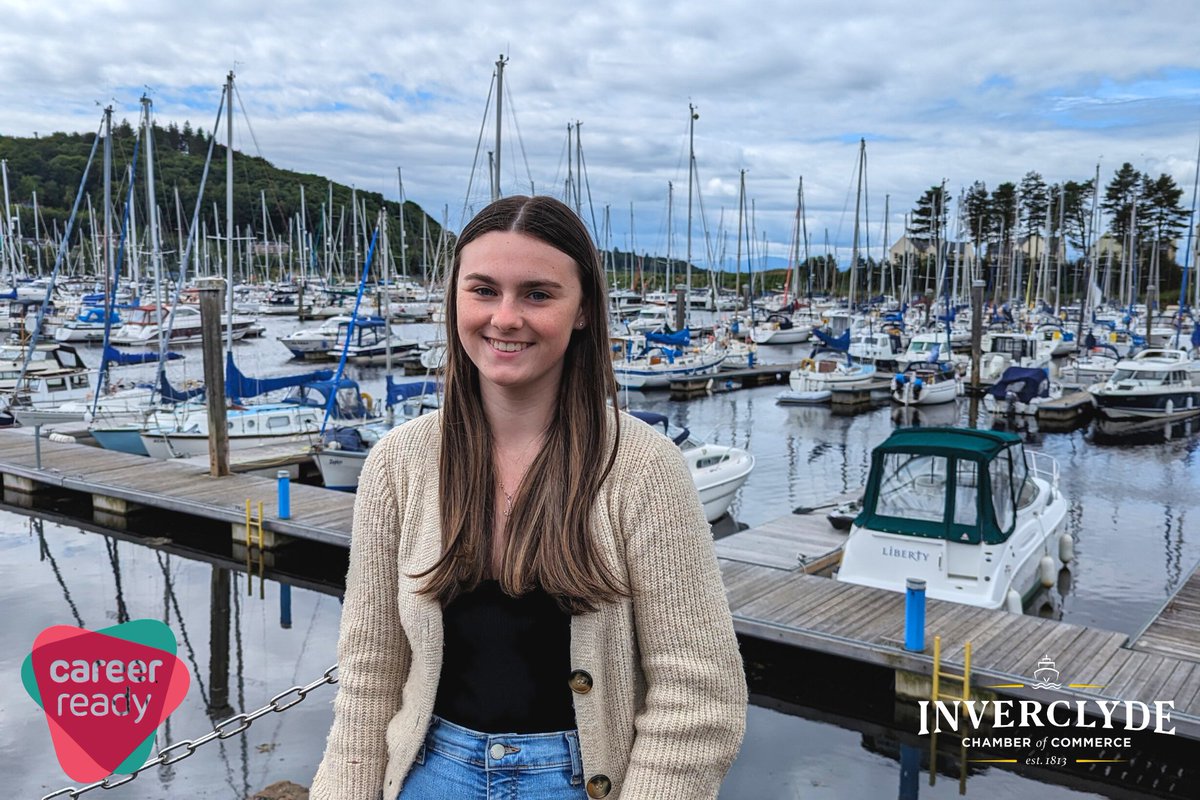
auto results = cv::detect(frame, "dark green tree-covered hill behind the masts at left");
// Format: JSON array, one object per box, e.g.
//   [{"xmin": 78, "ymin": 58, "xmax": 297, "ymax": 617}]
[{"xmin": 0, "ymin": 121, "xmax": 452, "ymax": 275}]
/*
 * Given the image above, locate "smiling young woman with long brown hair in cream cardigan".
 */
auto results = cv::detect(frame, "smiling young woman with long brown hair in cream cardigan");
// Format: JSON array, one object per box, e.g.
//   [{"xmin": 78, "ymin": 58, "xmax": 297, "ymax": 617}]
[{"xmin": 312, "ymin": 197, "xmax": 746, "ymax": 800}]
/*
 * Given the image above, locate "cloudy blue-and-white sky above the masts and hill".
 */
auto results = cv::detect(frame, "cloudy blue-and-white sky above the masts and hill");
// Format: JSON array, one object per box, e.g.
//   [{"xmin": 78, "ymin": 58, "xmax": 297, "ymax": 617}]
[{"xmin": 0, "ymin": 0, "xmax": 1200, "ymax": 264}]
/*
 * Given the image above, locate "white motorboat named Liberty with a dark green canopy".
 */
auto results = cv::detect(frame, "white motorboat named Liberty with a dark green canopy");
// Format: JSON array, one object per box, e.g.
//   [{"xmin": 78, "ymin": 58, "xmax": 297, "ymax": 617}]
[{"xmin": 836, "ymin": 428, "xmax": 1074, "ymax": 613}]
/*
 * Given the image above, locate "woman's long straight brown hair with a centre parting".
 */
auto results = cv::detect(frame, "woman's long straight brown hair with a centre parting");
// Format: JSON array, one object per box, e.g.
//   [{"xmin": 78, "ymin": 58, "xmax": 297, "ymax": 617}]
[{"xmin": 421, "ymin": 196, "xmax": 629, "ymax": 613}]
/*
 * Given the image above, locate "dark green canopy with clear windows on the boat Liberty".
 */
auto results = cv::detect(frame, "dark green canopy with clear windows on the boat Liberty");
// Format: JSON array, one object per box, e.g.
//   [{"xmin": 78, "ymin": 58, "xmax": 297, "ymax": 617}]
[{"xmin": 854, "ymin": 428, "xmax": 1028, "ymax": 545}]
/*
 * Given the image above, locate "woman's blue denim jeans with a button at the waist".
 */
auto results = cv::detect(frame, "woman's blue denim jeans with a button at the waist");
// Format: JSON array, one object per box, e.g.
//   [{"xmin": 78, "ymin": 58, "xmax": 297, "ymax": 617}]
[{"xmin": 396, "ymin": 716, "xmax": 588, "ymax": 800}]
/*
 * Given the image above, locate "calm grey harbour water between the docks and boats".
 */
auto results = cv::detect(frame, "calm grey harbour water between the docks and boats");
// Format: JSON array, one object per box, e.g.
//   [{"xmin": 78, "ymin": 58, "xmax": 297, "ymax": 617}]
[{"xmin": 0, "ymin": 320, "xmax": 1200, "ymax": 799}]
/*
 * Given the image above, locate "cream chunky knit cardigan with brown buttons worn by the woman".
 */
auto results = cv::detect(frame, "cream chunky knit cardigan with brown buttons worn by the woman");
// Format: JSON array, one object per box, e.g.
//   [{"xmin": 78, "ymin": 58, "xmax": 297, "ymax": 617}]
[{"xmin": 311, "ymin": 413, "xmax": 746, "ymax": 800}]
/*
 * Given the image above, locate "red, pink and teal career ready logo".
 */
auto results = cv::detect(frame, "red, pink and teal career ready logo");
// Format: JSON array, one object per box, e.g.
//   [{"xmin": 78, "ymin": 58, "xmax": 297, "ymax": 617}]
[{"xmin": 20, "ymin": 619, "xmax": 191, "ymax": 782}]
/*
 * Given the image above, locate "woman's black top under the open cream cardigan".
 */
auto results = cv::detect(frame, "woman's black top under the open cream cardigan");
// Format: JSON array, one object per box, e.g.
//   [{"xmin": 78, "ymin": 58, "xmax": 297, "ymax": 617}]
[{"xmin": 433, "ymin": 581, "xmax": 575, "ymax": 733}]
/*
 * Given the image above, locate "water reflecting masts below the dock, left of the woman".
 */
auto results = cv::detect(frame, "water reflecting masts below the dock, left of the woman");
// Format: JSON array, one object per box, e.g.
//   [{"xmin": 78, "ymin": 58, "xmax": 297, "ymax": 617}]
[{"xmin": 0, "ymin": 511, "xmax": 340, "ymax": 798}]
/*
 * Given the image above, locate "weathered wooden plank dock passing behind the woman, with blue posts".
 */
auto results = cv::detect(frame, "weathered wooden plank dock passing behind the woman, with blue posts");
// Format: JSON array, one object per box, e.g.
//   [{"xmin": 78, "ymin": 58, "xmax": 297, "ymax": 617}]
[{"xmin": 0, "ymin": 431, "xmax": 1200, "ymax": 739}]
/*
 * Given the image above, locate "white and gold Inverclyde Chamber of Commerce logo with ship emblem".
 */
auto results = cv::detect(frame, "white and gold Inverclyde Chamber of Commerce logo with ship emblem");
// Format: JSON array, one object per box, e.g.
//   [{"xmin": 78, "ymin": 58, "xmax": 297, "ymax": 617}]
[{"xmin": 917, "ymin": 655, "xmax": 1175, "ymax": 766}]
